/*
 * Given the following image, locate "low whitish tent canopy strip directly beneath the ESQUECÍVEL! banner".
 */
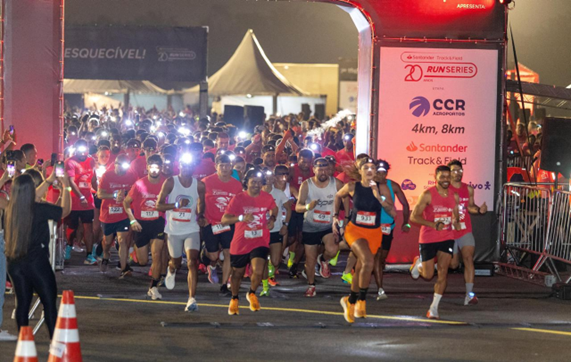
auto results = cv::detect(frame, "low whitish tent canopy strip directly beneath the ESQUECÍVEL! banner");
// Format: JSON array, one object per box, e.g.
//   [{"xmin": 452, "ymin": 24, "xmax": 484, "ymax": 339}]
[{"xmin": 63, "ymin": 79, "xmax": 174, "ymax": 95}]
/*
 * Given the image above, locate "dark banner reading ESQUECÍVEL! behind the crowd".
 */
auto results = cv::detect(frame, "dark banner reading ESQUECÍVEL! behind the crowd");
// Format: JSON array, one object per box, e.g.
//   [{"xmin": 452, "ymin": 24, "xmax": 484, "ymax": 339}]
[{"xmin": 64, "ymin": 26, "xmax": 208, "ymax": 82}]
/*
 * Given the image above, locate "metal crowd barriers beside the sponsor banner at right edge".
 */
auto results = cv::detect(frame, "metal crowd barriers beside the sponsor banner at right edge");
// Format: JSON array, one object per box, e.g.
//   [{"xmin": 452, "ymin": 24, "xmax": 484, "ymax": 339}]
[{"xmin": 497, "ymin": 183, "xmax": 571, "ymax": 285}]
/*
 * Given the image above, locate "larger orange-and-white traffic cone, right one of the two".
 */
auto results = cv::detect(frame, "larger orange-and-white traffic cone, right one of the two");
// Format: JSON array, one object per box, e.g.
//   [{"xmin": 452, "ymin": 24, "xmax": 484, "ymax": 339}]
[{"xmin": 48, "ymin": 290, "xmax": 82, "ymax": 362}]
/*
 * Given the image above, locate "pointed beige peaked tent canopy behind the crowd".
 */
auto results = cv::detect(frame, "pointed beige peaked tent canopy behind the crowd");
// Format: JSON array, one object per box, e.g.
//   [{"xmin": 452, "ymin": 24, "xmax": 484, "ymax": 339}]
[{"xmin": 186, "ymin": 29, "xmax": 307, "ymax": 96}]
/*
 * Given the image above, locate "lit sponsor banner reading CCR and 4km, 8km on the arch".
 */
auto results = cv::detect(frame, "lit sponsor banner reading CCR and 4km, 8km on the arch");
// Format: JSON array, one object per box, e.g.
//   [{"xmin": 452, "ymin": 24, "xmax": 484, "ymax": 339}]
[{"xmin": 378, "ymin": 47, "xmax": 498, "ymax": 210}]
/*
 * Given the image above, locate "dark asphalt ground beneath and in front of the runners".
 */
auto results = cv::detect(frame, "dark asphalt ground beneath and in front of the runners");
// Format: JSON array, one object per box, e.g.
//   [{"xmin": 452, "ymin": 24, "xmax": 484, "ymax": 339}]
[{"xmin": 0, "ymin": 253, "xmax": 571, "ymax": 362}]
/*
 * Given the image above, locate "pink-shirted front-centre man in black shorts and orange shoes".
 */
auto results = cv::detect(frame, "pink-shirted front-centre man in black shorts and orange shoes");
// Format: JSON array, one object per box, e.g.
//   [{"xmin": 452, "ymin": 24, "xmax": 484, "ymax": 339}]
[{"xmin": 222, "ymin": 169, "xmax": 278, "ymax": 315}]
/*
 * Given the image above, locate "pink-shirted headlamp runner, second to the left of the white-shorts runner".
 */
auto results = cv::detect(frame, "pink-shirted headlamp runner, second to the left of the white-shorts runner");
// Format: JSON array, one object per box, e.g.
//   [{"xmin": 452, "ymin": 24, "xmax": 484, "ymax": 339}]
[{"xmin": 97, "ymin": 154, "xmax": 137, "ymax": 279}]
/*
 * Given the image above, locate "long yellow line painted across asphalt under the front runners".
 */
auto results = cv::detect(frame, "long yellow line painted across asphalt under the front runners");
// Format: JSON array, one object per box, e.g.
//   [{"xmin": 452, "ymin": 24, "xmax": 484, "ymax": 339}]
[{"xmin": 68, "ymin": 295, "xmax": 469, "ymax": 325}]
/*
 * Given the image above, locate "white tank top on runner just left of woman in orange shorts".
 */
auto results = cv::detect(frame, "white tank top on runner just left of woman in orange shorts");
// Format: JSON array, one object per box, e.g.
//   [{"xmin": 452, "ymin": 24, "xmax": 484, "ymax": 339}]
[{"xmin": 303, "ymin": 177, "xmax": 337, "ymax": 233}]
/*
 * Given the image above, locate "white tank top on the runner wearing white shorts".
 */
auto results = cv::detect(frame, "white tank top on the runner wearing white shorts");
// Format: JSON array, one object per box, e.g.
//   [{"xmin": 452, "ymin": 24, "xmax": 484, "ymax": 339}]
[{"xmin": 165, "ymin": 176, "xmax": 200, "ymax": 235}]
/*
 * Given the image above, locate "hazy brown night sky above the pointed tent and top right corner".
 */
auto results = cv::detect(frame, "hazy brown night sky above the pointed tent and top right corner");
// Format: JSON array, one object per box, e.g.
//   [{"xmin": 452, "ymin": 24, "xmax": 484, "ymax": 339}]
[{"xmin": 66, "ymin": 0, "xmax": 571, "ymax": 86}]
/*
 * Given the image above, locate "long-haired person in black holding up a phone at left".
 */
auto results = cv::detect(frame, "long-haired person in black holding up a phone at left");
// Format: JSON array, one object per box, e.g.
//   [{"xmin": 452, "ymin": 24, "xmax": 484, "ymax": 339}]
[{"xmin": 0, "ymin": 168, "xmax": 71, "ymax": 338}]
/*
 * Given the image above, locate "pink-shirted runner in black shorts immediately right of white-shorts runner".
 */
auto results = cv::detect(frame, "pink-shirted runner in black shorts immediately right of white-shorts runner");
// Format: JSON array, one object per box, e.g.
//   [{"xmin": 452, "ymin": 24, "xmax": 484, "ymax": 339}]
[{"xmin": 198, "ymin": 155, "xmax": 242, "ymax": 294}]
